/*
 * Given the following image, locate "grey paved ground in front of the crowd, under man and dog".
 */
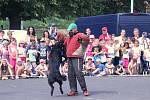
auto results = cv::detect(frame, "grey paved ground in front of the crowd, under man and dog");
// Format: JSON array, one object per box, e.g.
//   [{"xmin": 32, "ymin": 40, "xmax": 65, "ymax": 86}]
[{"xmin": 0, "ymin": 77, "xmax": 150, "ymax": 100}]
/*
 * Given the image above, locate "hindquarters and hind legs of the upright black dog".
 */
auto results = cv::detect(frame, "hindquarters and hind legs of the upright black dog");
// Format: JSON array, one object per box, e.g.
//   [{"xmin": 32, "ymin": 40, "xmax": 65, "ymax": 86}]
[{"xmin": 48, "ymin": 63, "xmax": 66, "ymax": 96}]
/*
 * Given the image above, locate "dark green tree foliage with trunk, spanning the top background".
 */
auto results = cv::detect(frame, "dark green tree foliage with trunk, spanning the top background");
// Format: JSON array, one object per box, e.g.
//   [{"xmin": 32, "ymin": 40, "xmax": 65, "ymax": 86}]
[{"xmin": 0, "ymin": 0, "xmax": 150, "ymax": 29}]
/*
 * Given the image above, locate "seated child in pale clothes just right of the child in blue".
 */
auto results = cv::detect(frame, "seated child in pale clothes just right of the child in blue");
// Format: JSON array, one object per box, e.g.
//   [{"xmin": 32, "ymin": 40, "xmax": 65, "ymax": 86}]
[{"xmin": 105, "ymin": 58, "xmax": 115, "ymax": 75}]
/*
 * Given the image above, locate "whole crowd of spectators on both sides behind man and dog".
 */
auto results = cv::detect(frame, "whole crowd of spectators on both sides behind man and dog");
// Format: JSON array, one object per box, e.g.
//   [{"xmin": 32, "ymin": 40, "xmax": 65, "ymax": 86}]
[{"xmin": 0, "ymin": 25, "xmax": 150, "ymax": 80}]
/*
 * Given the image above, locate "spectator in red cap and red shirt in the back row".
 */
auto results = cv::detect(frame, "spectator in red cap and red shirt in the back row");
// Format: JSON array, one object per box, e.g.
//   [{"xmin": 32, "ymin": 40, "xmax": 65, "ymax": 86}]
[{"xmin": 99, "ymin": 27, "xmax": 111, "ymax": 42}]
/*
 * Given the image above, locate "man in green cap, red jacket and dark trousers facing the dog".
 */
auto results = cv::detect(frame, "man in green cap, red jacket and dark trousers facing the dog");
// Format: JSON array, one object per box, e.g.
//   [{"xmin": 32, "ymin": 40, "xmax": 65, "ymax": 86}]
[{"xmin": 64, "ymin": 23, "xmax": 89, "ymax": 96}]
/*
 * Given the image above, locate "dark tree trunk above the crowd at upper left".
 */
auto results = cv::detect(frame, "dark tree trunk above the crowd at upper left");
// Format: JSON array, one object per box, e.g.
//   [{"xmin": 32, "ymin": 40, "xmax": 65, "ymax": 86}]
[{"xmin": 9, "ymin": 16, "xmax": 21, "ymax": 30}]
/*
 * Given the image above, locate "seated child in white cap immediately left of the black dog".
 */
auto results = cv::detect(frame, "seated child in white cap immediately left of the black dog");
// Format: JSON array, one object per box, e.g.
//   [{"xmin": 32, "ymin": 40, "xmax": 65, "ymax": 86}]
[{"xmin": 35, "ymin": 59, "xmax": 48, "ymax": 77}]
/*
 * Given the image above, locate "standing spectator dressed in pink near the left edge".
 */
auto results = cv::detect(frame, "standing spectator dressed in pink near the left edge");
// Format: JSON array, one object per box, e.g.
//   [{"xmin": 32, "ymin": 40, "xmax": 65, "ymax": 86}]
[{"xmin": 8, "ymin": 39, "xmax": 18, "ymax": 74}]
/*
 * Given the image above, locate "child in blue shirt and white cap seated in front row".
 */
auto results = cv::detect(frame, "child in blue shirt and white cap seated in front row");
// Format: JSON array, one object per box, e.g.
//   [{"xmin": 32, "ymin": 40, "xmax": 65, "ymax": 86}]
[{"xmin": 92, "ymin": 59, "xmax": 105, "ymax": 76}]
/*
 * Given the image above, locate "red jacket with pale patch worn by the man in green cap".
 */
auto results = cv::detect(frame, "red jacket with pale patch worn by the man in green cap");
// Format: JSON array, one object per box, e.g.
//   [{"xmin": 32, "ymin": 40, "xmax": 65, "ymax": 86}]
[{"xmin": 64, "ymin": 33, "xmax": 89, "ymax": 58}]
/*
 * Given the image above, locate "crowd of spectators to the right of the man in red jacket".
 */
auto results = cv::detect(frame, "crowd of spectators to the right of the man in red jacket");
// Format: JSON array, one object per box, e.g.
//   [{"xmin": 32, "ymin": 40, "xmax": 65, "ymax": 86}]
[{"xmin": 84, "ymin": 27, "xmax": 150, "ymax": 76}]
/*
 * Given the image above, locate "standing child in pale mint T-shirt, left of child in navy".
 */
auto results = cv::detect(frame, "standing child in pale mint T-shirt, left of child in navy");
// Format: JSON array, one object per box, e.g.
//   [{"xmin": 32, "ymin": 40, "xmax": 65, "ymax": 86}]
[{"xmin": 27, "ymin": 43, "xmax": 38, "ymax": 74}]
